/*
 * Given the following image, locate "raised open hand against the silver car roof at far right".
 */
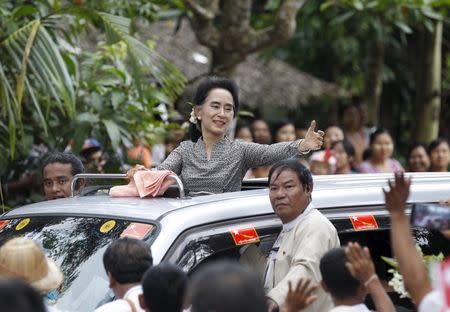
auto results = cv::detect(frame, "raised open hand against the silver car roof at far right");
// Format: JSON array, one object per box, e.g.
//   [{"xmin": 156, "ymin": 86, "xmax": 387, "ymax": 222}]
[{"xmin": 383, "ymin": 172, "xmax": 411, "ymax": 214}]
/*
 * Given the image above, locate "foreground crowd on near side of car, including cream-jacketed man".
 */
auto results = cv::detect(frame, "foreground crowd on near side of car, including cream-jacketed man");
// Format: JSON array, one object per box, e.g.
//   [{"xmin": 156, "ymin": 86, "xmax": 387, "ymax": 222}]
[{"xmin": 0, "ymin": 168, "xmax": 450, "ymax": 312}]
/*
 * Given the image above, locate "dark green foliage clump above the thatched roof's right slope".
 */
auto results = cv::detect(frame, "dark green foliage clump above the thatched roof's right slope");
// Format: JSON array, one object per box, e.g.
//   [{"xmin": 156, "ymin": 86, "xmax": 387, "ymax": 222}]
[{"xmin": 269, "ymin": 1, "xmax": 365, "ymax": 94}]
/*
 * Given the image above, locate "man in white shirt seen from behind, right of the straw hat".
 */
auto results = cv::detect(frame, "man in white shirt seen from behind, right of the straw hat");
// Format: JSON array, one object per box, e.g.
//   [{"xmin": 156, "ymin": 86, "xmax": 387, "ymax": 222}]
[{"xmin": 95, "ymin": 237, "xmax": 153, "ymax": 312}]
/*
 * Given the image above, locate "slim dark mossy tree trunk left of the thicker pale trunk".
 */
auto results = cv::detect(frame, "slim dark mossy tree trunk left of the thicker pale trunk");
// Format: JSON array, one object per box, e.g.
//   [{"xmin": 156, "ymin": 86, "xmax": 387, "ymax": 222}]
[{"xmin": 364, "ymin": 41, "xmax": 384, "ymax": 126}]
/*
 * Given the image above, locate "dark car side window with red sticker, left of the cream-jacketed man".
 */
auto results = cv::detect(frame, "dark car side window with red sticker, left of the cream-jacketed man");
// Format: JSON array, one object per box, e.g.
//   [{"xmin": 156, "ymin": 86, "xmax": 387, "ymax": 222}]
[{"xmin": 164, "ymin": 216, "xmax": 281, "ymax": 272}]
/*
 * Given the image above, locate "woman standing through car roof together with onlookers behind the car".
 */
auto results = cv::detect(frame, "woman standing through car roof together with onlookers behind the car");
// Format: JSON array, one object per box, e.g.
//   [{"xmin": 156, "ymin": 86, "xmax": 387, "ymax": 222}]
[{"xmin": 2, "ymin": 77, "xmax": 450, "ymax": 206}]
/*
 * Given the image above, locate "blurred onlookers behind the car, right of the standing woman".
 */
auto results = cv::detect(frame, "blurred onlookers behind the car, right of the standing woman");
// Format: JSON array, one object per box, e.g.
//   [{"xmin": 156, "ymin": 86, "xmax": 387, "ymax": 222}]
[{"xmin": 235, "ymin": 112, "xmax": 450, "ymax": 178}]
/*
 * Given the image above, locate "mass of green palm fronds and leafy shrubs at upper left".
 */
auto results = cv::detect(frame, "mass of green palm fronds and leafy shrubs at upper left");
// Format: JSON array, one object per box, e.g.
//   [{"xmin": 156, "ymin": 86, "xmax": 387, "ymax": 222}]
[{"xmin": 0, "ymin": 0, "xmax": 186, "ymax": 165}]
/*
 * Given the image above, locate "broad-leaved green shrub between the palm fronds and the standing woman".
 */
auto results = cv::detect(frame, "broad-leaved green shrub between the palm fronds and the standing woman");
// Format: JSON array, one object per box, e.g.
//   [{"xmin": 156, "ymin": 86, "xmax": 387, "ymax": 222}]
[{"xmin": 67, "ymin": 41, "xmax": 178, "ymax": 152}]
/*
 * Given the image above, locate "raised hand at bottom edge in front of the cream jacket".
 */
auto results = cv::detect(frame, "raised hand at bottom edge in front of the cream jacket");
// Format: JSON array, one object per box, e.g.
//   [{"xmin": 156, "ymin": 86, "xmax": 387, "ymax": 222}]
[{"xmin": 284, "ymin": 278, "xmax": 317, "ymax": 312}]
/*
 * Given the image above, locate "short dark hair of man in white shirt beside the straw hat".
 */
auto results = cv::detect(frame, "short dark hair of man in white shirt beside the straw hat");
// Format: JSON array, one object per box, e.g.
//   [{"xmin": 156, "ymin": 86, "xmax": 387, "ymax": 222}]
[{"xmin": 103, "ymin": 237, "xmax": 153, "ymax": 284}]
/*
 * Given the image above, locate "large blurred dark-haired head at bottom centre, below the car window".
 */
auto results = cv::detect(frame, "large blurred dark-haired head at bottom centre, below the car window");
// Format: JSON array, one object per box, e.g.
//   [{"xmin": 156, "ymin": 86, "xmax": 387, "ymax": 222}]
[{"xmin": 190, "ymin": 261, "xmax": 267, "ymax": 312}]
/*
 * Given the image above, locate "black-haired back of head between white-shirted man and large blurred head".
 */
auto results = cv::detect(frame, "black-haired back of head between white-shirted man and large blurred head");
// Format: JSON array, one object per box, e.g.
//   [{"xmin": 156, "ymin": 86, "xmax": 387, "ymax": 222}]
[{"xmin": 142, "ymin": 263, "xmax": 188, "ymax": 312}]
